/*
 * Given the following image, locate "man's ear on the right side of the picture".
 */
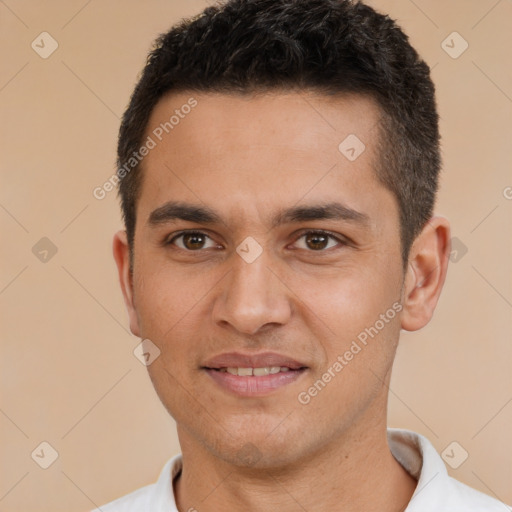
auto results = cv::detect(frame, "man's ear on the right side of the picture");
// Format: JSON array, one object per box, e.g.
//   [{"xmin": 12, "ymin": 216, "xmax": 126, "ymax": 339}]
[{"xmin": 401, "ymin": 217, "xmax": 450, "ymax": 331}]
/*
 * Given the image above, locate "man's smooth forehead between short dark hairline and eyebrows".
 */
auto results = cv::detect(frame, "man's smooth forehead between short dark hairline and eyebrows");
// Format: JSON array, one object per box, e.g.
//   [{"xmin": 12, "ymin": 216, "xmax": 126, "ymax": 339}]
[{"xmin": 136, "ymin": 91, "xmax": 392, "ymax": 230}]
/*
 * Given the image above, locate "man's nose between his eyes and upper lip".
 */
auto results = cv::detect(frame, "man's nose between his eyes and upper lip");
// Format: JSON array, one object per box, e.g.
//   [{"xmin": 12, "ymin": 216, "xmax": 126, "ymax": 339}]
[{"xmin": 213, "ymin": 251, "xmax": 291, "ymax": 335}]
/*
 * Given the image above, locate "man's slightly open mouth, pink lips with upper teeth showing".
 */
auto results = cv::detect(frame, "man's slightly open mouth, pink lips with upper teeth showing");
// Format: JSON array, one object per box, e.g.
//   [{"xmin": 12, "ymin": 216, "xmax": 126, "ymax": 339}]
[{"xmin": 201, "ymin": 352, "xmax": 308, "ymax": 396}]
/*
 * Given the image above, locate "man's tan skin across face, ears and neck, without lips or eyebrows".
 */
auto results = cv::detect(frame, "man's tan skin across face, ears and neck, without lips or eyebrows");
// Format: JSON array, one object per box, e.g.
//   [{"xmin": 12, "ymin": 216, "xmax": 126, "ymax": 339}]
[{"xmin": 113, "ymin": 91, "xmax": 449, "ymax": 512}]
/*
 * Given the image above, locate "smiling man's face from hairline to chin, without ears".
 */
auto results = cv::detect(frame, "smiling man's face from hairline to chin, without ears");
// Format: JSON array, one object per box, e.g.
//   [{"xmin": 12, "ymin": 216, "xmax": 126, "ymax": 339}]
[{"xmin": 118, "ymin": 92, "xmax": 404, "ymax": 467}]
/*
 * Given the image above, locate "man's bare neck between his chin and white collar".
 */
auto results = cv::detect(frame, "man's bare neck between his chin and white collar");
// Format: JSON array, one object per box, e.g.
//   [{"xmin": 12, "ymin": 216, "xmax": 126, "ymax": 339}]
[{"xmin": 174, "ymin": 418, "xmax": 417, "ymax": 512}]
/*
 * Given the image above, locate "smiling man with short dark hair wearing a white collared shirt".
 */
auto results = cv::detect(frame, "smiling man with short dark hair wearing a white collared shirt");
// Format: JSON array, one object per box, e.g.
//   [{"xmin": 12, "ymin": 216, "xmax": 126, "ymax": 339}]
[{"xmin": 96, "ymin": 0, "xmax": 506, "ymax": 512}]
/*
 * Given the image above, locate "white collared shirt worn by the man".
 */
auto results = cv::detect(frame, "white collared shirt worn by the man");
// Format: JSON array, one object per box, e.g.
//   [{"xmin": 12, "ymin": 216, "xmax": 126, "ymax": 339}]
[{"xmin": 93, "ymin": 428, "xmax": 512, "ymax": 512}]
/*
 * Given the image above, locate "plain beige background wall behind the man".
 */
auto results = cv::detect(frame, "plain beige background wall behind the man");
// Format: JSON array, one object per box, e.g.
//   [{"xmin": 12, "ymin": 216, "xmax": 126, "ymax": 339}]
[{"xmin": 0, "ymin": 0, "xmax": 512, "ymax": 512}]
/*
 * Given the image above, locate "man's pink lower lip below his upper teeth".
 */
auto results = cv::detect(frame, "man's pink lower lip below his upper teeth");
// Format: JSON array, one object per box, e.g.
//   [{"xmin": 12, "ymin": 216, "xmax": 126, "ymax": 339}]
[{"xmin": 205, "ymin": 368, "xmax": 306, "ymax": 396}]
